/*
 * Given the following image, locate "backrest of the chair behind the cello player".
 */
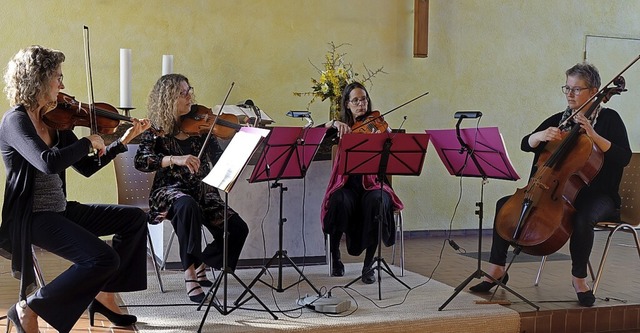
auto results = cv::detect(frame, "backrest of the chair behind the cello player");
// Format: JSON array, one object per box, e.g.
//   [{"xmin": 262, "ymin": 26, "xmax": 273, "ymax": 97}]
[{"xmin": 618, "ymin": 153, "xmax": 640, "ymax": 226}]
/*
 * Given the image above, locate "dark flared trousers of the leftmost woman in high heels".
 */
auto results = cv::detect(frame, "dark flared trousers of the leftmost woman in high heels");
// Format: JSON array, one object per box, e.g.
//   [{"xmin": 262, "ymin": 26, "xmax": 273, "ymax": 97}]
[{"xmin": 26, "ymin": 202, "xmax": 147, "ymax": 332}]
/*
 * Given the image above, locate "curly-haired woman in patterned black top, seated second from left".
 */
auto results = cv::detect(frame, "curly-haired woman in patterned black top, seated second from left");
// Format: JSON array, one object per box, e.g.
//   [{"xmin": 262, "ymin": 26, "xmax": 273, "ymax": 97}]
[{"xmin": 135, "ymin": 74, "xmax": 249, "ymax": 303}]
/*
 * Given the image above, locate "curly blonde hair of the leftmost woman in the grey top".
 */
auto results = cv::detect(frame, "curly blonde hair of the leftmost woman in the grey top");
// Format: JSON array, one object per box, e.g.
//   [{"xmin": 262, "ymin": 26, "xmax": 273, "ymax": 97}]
[{"xmin": 4, "ymin": 45, "xmax": 65, "ymax": 108}]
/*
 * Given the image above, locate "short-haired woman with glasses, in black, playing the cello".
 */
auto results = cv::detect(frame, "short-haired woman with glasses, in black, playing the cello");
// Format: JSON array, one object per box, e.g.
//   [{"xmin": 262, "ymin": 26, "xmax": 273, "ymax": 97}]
[{"xmin": 470, "ymin": 63, "xmax": 631, "ymax": 306}]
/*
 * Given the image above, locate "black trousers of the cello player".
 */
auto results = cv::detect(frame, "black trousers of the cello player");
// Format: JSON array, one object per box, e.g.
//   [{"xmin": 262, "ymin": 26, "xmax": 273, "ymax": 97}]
[{"xmin": 489, "ymin": 194, "xmax": 619, "ymax": 278}]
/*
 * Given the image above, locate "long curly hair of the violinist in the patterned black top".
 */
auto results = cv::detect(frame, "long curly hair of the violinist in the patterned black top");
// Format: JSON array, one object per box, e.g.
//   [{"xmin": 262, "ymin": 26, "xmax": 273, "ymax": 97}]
[{"xmin": 147, "ymin": 74, "xmax": 189, "ymax": 135}]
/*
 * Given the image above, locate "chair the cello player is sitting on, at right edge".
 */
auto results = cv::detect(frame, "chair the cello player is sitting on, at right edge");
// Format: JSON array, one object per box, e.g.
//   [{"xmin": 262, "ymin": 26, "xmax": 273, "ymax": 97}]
[{"xmin": 535, "ymin": 153, "xmax": 640, "ymax": 294}]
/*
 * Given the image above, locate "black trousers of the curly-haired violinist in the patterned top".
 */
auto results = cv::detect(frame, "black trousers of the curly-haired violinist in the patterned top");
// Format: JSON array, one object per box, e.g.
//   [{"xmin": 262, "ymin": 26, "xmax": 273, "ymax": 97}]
[{"xmin": 167, "ymin": 196, "xmax": 249, "ymax": 270}]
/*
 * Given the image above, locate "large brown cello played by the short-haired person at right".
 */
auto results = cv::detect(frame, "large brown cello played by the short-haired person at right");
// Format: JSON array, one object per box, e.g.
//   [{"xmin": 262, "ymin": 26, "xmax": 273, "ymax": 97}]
[{"xmin": 495, "ymin": 63, "xmax": 640, "ymax": 256}]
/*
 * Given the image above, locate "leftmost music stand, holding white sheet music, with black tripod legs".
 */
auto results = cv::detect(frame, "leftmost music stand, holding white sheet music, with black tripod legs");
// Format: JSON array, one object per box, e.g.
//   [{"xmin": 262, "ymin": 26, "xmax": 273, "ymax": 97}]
[{"xmin": 198, "ymin": 127, "xmax": 278, "ymax": 332}]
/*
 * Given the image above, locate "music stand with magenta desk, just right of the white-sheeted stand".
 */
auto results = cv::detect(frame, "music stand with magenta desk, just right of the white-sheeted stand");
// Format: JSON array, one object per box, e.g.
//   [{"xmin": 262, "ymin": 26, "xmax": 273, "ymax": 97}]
[{"xmin": 238, "ymin": 127, "xmax": 327, "ymax": 301}]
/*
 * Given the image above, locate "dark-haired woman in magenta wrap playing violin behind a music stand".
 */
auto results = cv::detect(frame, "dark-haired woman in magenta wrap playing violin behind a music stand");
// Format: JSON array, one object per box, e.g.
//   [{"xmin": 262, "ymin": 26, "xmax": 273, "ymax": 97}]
[{"xmin": 321, "ymin": 82, "xmax": 403, "ymax": 284}]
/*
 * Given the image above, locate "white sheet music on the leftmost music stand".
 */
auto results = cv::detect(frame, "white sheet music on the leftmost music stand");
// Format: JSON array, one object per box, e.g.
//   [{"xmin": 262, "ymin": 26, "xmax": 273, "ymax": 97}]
[{"xmin": 202, "ymin": 127, "xmax": 269, "ymax": 193}]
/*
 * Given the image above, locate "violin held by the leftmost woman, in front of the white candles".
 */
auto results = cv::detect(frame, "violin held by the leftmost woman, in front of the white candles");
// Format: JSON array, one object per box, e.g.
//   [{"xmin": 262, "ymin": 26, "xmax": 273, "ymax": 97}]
[{"xmin": 42, "ymin": 92, "xmax": 141, "ymax": 134}]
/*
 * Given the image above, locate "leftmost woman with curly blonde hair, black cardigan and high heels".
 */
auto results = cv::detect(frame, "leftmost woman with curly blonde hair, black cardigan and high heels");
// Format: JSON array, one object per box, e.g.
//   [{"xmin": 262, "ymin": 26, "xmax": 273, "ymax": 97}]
[{"xmin": 0, "ymin": 46, "xmax": 150, "ymax": 332}]
